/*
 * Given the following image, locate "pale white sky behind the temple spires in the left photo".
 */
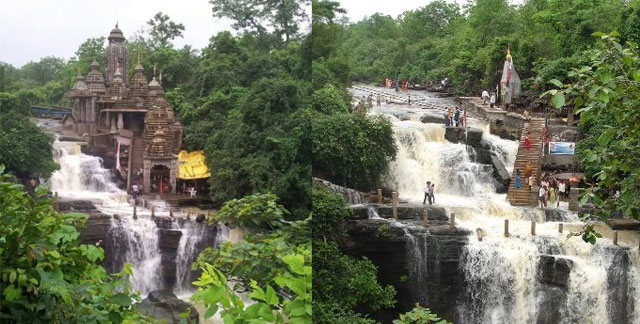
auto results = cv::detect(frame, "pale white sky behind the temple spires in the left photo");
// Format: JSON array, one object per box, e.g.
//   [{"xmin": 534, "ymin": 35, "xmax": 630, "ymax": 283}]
[{"xmin": 0, "ymin": 0, "xmax": 231, "ymax": 67}]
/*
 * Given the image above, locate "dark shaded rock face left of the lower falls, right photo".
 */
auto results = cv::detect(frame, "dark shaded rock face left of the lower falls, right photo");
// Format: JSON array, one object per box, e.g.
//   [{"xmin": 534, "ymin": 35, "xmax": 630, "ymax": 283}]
[{"xmin": 346, "ymin": 219, "xmax": 470, "ymax": 322}]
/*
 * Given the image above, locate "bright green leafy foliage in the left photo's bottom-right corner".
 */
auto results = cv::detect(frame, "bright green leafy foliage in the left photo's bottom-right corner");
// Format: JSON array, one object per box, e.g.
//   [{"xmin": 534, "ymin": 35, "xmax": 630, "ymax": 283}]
[{"xmin": 192, "ymin": 194, "xmax": 312, "ymax": 323}]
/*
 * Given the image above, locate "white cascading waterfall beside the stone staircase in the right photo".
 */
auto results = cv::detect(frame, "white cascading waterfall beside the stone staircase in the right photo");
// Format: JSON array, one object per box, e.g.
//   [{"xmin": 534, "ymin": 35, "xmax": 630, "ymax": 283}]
[{"xmin": 357, "ymin": 86, "xmax": 640, "ymax": 324}]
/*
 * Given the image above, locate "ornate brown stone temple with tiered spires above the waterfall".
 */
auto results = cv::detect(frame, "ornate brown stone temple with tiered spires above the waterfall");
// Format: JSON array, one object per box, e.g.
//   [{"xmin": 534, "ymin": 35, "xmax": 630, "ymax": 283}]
[{"xmin": 69, "ymin": 24, "xmax": 182, "ymax": 193}]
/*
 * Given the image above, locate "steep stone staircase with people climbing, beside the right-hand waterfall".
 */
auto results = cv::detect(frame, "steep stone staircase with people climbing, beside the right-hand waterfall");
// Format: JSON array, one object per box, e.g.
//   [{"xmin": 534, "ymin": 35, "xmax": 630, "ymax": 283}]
[{"xmin": 507, "ymin": 118, "xmax": 544, "ymax": 206}]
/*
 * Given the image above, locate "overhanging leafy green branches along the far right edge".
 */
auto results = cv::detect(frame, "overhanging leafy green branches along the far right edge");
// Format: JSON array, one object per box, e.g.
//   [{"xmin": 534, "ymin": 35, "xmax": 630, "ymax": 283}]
[{"xmin": 544, "ymin": 33, "xmax": 640, "ymax": 243}]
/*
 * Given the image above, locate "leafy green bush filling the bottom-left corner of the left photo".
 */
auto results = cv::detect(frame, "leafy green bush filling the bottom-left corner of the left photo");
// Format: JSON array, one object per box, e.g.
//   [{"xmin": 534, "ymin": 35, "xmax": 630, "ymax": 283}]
[{"xmin": 0, "ymin": 167, "xmax": 148, "ymax": 323}]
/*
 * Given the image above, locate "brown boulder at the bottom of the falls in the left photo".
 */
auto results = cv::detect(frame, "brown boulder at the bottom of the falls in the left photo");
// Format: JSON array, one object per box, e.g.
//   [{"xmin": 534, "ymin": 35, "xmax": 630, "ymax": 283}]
[{"xmin": 137, "ymin": 290, "xmax": 199, "ymax": 324}]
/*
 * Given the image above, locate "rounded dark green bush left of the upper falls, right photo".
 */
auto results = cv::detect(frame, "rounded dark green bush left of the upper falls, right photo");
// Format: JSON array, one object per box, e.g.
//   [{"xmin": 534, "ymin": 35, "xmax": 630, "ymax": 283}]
[{"xmin": 312, "ymin": 113, "xmax": 397, "ymax": 191}]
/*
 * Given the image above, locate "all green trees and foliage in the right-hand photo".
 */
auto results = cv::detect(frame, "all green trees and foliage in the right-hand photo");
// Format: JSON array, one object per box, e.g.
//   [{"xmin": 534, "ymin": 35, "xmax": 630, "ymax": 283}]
[{"xmin": 312, "ymin": 0, "xmax": 640, "ymax": 323}]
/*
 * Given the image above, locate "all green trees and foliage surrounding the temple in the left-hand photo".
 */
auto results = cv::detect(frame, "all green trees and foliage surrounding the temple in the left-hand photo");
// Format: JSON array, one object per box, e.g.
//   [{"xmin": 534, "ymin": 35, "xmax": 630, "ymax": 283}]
[{"xmin": 0, "ymin": 0, "xmax": 311, "ymax": 323}]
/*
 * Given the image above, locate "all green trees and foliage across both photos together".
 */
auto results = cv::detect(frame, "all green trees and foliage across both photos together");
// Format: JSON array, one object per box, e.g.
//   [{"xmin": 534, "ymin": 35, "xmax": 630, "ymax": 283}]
[{"xmin": 0, "ymin": 0, "xmax": 640, "ymax": 324}]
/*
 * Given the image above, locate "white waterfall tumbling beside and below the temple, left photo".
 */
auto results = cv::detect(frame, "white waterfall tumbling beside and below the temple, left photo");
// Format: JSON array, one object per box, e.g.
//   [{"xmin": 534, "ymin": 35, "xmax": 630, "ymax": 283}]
[{"xmin": 49, "ymin": 141, "xmax": 226, "ymax": 296}]
